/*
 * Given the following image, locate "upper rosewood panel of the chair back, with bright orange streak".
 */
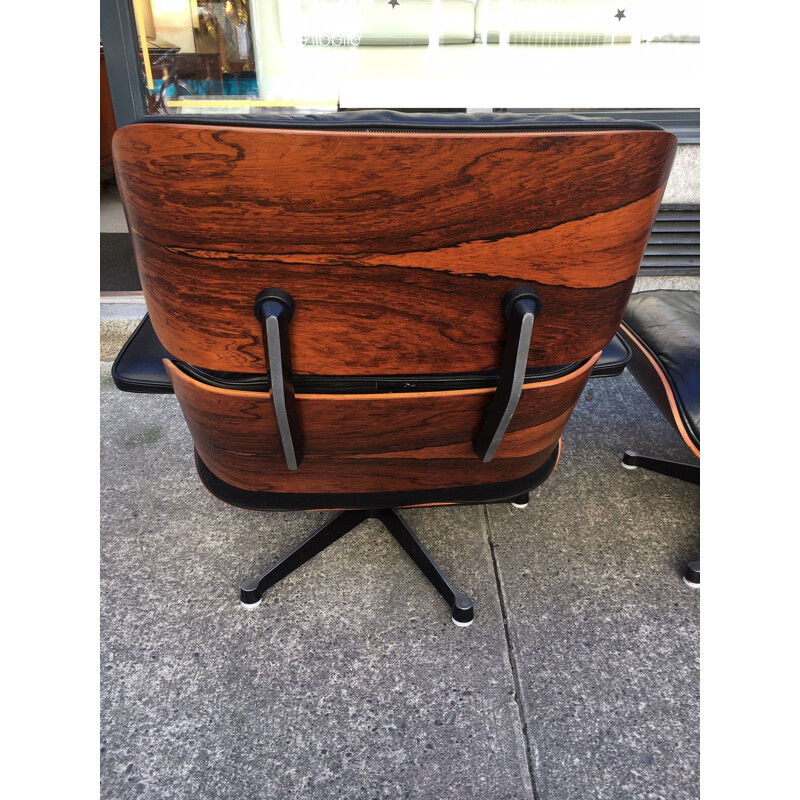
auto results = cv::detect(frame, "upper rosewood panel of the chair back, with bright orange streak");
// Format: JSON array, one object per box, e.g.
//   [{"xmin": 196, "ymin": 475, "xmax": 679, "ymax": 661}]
[{"xmin": 114, "ymin": 124, "xmax": 676, "ymax": 375}]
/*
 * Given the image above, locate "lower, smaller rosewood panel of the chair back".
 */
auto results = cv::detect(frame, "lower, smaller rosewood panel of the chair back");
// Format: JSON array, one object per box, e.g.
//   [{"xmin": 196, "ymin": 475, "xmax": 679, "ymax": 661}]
[{"xmin": 164, "ymin": 353, "xmax": 600, "ymax": 493}]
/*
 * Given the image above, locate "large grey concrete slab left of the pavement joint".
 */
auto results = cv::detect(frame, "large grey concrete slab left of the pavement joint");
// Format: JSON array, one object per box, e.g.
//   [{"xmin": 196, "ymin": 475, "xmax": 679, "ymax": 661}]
[{"xmin": 101, "ymin": 364, "xmax": 532, "ymax": 800}]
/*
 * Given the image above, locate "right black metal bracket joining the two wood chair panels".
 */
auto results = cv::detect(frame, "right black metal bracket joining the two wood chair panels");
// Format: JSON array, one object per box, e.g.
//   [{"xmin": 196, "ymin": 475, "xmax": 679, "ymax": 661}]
[{"xmin": 472, "ymin": 286, "xmax": 542, "ymax": 462}]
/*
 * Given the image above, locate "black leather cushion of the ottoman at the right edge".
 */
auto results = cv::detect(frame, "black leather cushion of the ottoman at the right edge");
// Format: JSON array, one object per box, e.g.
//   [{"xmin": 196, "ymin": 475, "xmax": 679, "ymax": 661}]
[{"xmin": 623, "ymin": 289, "xmax": 700, "ymax": 446}]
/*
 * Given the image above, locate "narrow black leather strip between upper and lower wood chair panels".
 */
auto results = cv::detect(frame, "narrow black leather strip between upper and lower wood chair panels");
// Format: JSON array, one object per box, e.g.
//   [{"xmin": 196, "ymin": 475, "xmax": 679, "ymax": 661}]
[{"xmin": 173, "ymin": 359, "xmax": 586, "ymax": 394}]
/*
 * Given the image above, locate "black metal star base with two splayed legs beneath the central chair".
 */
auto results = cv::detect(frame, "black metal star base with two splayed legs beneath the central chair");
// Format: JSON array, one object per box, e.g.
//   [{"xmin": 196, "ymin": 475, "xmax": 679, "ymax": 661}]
[{"xmin": 239, "ymin": 508, "xmax": 475, "ymax": 627}]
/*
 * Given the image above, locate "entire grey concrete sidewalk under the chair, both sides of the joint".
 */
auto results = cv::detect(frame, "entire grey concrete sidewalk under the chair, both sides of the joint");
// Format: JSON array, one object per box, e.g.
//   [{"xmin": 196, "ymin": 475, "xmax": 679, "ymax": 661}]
[{"xmin": 101, "ymin": 363, "xmax": 699, "ymax": 800}]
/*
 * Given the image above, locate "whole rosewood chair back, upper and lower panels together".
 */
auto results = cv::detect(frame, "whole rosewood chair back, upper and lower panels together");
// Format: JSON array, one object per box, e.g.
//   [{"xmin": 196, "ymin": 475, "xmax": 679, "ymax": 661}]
[{"xmin": 114, "ymin": 115, "xmax": 676, "ymax": 508}]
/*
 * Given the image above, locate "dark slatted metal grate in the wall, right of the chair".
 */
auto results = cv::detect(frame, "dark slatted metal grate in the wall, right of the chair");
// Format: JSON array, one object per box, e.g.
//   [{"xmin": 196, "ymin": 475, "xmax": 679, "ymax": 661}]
[{"xmin": 640, "ymin": 205, "xmax": 700, "ymax": 275}]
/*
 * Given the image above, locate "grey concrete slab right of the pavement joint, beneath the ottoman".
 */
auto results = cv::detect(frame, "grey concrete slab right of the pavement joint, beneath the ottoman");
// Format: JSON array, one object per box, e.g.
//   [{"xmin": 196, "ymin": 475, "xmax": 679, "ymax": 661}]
[{"xmin": 487, "ymin": 373, "xmax": 699, "ymax": 800}]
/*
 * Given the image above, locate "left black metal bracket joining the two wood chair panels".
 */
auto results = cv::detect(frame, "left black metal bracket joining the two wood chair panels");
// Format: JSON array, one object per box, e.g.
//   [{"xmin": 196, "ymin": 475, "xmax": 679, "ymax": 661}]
[{"xmin": 254, "ymin": 288, "xmax": 303, "ymax": 470}]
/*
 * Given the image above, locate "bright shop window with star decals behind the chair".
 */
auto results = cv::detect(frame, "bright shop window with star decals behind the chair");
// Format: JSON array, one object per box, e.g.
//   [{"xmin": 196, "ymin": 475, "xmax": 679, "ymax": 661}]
[{"xmin": 128, "ymin": 0, "xmax": 700, "ymax": 113}]
